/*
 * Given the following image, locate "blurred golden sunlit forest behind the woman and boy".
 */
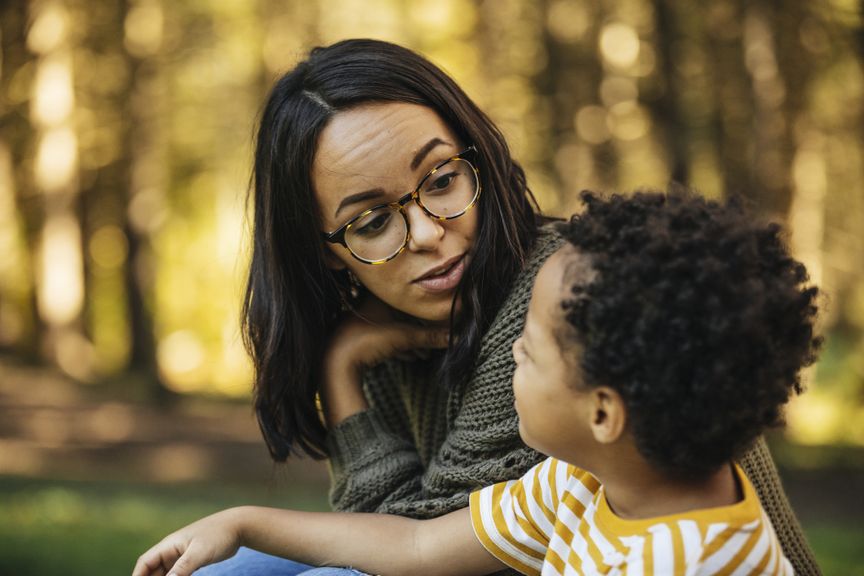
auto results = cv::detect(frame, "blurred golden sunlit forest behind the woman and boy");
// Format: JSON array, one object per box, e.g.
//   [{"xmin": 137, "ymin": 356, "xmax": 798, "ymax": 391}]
[{"xmin": 0, "ymin": 0, "xmax": 864, "ymax": 445}]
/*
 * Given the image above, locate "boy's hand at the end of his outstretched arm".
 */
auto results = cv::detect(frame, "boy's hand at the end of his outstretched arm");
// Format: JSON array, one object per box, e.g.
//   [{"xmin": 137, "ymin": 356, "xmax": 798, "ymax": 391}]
[{"xmin": 132, "ymin": 509, "xmax": 240, "ymax": 576}]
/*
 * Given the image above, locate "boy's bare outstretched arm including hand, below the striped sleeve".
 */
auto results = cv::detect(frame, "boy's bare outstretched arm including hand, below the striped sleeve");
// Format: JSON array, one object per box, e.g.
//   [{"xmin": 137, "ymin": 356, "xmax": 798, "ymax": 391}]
[{"xmin": 132, "ymin": 506, "xmax": 504, "ymax": 576}]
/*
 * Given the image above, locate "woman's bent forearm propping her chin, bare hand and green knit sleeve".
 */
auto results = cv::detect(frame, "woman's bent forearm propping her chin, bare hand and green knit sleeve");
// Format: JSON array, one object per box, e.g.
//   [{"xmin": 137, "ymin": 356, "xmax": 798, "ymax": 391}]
[{"xmin": 321, "ymin": 295, "xmax": 447, "ymax": 512}]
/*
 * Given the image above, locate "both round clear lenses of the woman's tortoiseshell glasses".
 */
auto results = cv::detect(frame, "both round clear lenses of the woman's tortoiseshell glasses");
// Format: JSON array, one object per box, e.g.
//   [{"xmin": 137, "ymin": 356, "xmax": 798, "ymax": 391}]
[{"xmin": 345, "ymin": 158, "xmax": 479, "ymax": 262}]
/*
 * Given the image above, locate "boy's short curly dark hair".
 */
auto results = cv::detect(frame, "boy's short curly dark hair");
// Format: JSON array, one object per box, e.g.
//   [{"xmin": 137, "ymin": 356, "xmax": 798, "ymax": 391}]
[{"xmin": 562, "ymin": 190, "xmax": 821, "ymax": 477}]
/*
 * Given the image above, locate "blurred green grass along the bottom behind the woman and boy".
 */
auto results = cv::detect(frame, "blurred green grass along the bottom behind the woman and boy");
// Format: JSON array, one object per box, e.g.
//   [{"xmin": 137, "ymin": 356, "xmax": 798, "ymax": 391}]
[{"xmin": 0, "ymin": 477, "xmax": 864, "ymax": 576}]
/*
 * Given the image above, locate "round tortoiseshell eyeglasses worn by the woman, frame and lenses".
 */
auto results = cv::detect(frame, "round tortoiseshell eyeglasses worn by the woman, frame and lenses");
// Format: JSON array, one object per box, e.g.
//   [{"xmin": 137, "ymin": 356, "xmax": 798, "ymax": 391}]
[{"xmin": 322, "ymin": 146, "xmax": 480, "ymax": 264}]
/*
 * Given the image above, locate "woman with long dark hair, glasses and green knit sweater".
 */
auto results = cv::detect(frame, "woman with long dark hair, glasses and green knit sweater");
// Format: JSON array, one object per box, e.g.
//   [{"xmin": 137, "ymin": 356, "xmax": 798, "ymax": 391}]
[{"xmin": 199, "ymin": 40, "xmax": 817, "ymax": 575}]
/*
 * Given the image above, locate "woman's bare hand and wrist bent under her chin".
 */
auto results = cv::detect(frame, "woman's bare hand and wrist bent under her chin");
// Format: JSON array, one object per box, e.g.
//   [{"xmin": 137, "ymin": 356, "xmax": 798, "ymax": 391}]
[{"xmin": 321, "ymin": 294, "xmax": 449, "ymax": 427}]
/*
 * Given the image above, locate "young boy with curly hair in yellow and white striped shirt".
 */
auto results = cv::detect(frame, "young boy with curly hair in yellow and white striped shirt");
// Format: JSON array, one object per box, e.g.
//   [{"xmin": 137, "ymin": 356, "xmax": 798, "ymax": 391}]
[{"xmin": 133, "ymin": 192, "xmax": 820, "ymax": 576}]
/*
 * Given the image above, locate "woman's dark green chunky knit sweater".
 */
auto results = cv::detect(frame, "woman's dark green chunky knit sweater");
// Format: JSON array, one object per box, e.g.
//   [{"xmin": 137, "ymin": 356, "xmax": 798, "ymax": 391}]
[{"xmin": 328, "ymin": 224, "xmax": 819, "ymax": 575}]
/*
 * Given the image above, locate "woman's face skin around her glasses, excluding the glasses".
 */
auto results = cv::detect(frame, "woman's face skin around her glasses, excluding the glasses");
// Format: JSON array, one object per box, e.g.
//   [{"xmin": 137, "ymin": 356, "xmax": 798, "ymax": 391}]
[{"xmin": 312, "ymin": 102, "xmax": 478, "ymax": 323}]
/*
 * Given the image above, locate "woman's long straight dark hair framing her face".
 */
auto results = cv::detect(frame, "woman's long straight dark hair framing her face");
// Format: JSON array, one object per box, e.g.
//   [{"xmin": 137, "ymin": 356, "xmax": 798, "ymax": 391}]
[{"xmin": 242, "ymin": 40, "xmax": 537, "ymax": 461}]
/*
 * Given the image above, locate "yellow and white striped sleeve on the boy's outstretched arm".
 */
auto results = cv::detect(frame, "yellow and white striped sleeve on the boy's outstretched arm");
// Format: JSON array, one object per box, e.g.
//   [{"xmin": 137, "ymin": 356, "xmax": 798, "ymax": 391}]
[{"xmin": 470, "ymin": 458, "xmax": 566, "ymax": 574}]
